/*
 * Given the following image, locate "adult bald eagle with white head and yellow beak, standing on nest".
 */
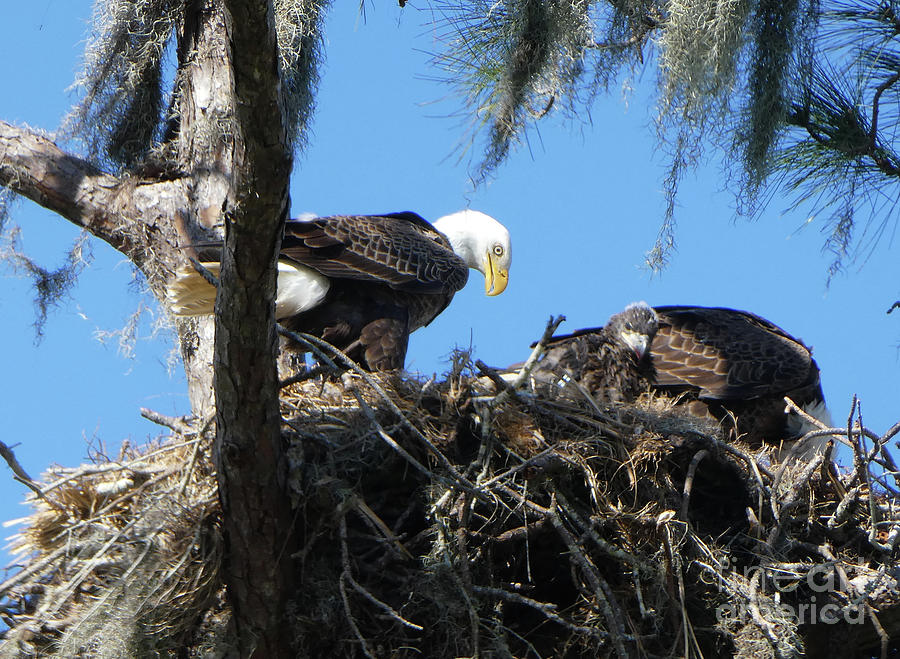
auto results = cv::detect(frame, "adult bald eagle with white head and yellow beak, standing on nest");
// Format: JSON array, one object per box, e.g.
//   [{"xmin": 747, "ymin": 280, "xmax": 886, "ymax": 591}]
[{"xmin": 168, "ymin": 210, "xmax": 512, "ymax": 371}]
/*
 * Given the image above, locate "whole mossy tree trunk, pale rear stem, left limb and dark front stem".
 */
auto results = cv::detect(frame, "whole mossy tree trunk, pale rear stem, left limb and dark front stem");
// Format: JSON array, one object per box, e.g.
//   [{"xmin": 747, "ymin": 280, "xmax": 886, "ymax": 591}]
[{"xmin": 0, "ymin": 0, "xmax": 294, "ymax": 657}]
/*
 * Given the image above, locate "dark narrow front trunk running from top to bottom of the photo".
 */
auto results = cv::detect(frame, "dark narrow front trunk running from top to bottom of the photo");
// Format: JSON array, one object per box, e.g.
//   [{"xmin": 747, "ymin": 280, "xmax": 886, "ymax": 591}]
[{"xmin": 214, "ymin": 0, "xmax": 295, "ymax": 657}]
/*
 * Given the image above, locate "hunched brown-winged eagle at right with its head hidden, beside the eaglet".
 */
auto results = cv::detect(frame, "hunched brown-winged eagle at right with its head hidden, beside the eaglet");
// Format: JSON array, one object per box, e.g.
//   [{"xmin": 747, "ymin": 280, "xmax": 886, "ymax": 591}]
[{"xmin": 545, "ymin": 306, "xmax": 830, "ymax": 445}]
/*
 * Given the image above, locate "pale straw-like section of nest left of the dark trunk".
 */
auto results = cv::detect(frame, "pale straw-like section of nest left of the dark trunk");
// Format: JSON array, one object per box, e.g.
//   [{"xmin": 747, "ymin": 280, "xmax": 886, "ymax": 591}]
[{"xmin": 0, "ymin": 428, "xmax": 222, "ymax": 657}]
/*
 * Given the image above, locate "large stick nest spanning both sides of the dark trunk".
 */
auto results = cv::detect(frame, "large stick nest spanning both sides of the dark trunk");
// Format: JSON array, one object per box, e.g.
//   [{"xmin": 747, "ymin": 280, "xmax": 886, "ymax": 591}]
[{"xmin": 0, "ymin": 340, "xmax": 900, "ymax": 658}]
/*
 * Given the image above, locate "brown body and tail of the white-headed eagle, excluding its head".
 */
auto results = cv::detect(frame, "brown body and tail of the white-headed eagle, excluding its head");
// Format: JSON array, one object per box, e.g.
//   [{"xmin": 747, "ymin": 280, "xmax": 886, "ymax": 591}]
[{"xmin": 169, "ymin": 212, "xmax": 469, "ymax": 370}]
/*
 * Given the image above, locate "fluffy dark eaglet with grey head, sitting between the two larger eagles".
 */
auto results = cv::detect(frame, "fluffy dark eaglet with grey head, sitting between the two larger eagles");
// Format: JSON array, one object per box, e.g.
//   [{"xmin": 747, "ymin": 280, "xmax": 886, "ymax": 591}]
[{"xmin": 531, "ymin": 302, "xmax": 657, "ymax": 402}]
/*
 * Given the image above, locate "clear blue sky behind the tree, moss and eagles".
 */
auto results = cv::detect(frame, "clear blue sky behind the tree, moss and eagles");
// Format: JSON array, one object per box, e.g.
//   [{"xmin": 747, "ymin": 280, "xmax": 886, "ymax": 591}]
[{"xmin": 0, "ymin": 0, "xmax": 900, "ymax": 552}]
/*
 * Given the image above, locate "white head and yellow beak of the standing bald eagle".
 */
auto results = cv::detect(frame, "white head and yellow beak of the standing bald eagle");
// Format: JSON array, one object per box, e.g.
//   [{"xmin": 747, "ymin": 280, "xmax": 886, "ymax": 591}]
[{"xmin": 434, "ymin": 209, "xmax": 512, "ymax": 295}]
